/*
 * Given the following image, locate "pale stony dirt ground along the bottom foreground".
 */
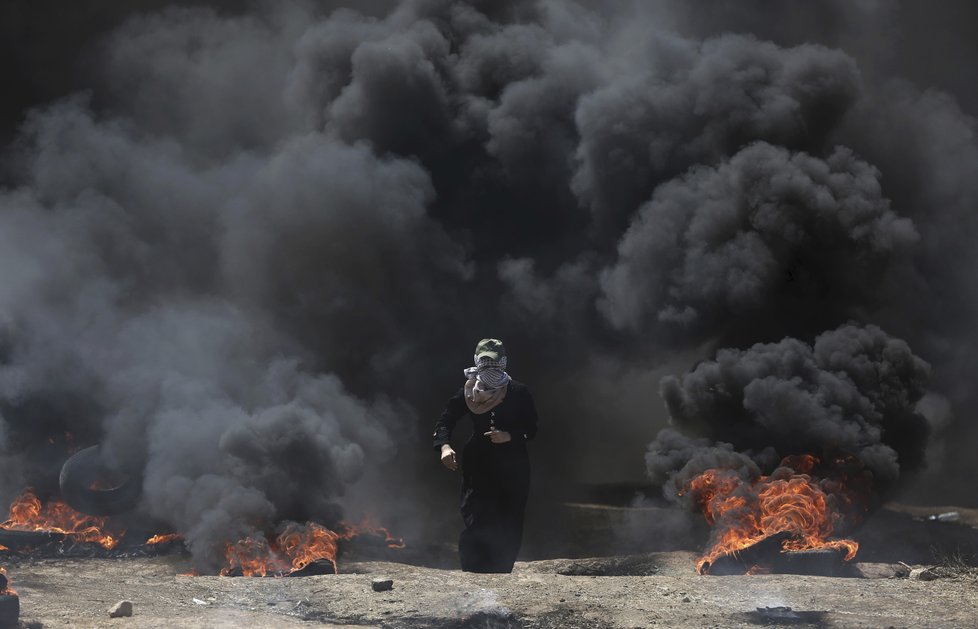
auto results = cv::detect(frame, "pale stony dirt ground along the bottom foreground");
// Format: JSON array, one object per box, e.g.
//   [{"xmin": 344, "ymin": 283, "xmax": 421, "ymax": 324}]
[{"xmin": 4, "ymin": 507, "xmax": 978, "ymax": 629}]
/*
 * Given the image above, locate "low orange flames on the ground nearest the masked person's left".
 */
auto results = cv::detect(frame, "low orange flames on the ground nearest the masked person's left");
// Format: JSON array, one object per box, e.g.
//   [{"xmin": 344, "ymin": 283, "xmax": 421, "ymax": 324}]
[{"xmin": 221, "ymin": 520, "xmax": 404, "ymax": 577}]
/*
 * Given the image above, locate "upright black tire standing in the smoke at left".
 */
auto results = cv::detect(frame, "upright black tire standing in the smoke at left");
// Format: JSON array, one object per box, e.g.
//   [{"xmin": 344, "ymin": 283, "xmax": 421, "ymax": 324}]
[{"xmin": 60, "ymin": 446, "xmax": 142, "ymax": 515}]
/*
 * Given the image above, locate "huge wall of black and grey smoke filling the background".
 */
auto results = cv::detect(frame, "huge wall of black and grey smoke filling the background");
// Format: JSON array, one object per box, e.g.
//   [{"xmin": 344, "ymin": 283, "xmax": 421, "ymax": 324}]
[{"xmin": 0, "ymin": 0, "xmax": 978, "ymax": 569}]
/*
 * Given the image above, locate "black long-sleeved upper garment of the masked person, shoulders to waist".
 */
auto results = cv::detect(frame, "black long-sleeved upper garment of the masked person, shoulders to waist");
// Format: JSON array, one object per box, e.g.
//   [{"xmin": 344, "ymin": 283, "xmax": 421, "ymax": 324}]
[{"xmin": 433, "ymin": 380, "xmax": 537, "ymax": 449}]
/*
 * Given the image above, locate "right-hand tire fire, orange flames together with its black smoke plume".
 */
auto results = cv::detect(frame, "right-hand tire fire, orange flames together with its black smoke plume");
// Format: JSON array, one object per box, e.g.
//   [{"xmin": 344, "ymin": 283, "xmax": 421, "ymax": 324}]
[{"xmin": 646, "ymin": 325, "xmax": 929, "ymax": 573}]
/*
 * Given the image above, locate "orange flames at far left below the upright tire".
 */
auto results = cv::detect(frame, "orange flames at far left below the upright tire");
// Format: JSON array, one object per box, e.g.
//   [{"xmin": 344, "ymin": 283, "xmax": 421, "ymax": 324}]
[{"xmin": 0, "ymin": 488, "xmax": 122, "ymax": 550}]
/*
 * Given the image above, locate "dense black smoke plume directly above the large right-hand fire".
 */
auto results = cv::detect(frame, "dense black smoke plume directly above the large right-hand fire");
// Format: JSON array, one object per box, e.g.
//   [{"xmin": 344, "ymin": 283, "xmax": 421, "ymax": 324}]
[{"xmin": 645, "ymin": 325, "xmax": 930, "ymax": 506}]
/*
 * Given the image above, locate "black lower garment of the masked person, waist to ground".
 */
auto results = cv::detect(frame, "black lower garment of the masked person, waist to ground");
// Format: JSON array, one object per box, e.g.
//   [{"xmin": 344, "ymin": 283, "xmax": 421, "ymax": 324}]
[{"xmin": 458, "ymin": 437, "xmax": 530, "ymax": 572}]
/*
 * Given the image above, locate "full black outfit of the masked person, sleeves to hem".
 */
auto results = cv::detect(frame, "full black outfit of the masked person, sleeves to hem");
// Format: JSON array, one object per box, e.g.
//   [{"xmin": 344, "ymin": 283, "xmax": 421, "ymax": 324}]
[{"xmin": 434, "ymin": 381, "xmax": 537, "ymax": 572}]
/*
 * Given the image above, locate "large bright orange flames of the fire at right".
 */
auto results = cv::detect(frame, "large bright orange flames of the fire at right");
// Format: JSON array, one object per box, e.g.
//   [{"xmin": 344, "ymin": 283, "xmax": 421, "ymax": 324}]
[{"xmin": 680, "ymin": 455, "xmax": 859, "ymax": 574}]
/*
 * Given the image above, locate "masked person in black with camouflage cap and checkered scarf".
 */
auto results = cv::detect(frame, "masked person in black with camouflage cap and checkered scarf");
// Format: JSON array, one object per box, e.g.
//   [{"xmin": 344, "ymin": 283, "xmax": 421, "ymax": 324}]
[{"xmin": 433, "ymin": 339, "xmax": 537, "ymax": 572}]
